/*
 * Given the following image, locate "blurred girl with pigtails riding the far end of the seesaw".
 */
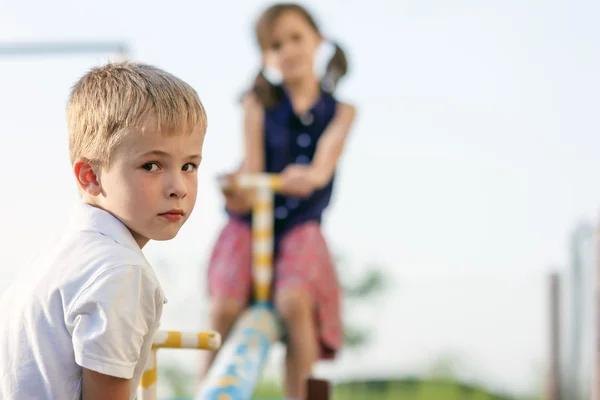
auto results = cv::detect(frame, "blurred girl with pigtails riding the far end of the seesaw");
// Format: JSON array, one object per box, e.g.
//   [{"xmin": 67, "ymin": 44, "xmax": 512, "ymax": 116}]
[{"xmin": 208, "ymin": 3, "xmax": 355, "ymax": 399}]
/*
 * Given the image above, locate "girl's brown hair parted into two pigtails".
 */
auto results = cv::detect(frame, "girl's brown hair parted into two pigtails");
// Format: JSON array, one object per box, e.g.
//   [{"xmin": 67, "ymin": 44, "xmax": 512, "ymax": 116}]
[{"xmin": 245, "ymin": 3, "xmax": 348, "ymax": 109}]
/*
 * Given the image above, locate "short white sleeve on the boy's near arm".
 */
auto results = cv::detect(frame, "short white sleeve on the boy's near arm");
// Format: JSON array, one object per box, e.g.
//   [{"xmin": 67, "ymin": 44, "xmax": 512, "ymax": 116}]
[{"xmin": 67, "ymin": 266, "xmax": 163, "ymax": 379}]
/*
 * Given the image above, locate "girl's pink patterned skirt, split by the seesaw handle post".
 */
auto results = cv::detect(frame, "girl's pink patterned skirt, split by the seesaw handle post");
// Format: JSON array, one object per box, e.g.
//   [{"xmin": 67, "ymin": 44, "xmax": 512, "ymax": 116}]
[{"xmin": 208, "ymin": 218, "xmax": 343, "ymax": 359}]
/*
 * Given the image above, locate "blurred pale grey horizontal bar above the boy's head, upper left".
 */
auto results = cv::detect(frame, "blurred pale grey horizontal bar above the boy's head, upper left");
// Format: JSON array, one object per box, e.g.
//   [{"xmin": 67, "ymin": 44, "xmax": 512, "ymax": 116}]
[{"xmin": 0, "ymin": 42, "xmax": 129, "ymax": 60}]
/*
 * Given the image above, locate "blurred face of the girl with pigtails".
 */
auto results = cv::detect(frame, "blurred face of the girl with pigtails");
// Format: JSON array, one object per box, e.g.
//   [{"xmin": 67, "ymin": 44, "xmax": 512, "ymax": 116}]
[{"xmin": 265, "ymin": 11, "xmax": 321, "ymax": 83}]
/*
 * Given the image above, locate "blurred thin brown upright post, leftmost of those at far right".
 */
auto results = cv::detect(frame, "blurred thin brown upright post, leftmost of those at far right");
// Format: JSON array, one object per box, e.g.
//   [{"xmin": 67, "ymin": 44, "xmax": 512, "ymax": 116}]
[{"xmin": 547, "ymin": 272, "xmax": 563, "ymax": 400}]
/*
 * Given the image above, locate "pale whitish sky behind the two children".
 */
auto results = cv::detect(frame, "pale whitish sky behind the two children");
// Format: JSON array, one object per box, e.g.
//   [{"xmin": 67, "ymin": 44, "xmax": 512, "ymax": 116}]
[{"xmin": 0, "ymin": 0, "xmax": 600, "ymax": 391}]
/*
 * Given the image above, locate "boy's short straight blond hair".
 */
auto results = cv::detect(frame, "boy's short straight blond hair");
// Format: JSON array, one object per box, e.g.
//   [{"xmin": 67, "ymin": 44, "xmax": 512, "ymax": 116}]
[{"xmin": 67, "ymin": 61, "xmax": 207, "ymax": 168}]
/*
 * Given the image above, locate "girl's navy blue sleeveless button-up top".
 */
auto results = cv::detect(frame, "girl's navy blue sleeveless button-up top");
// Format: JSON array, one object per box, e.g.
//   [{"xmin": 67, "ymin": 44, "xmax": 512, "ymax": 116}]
[{"xmin": 232, "ymin": 89, "xmax": 337, "ymax": 243}]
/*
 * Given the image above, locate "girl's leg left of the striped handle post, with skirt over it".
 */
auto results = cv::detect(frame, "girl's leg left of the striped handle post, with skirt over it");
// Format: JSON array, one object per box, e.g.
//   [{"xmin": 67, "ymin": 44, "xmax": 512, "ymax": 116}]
[{"xmin": 200, "ymin": 219, "xmax": 252, "ymax": 379}]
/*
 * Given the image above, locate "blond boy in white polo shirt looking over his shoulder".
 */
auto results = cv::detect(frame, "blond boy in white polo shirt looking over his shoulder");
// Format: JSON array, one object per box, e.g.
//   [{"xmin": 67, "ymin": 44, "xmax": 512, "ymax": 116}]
[{"xmin": 0, "ymin": 62, "xmax": 206, "ymax": 400}]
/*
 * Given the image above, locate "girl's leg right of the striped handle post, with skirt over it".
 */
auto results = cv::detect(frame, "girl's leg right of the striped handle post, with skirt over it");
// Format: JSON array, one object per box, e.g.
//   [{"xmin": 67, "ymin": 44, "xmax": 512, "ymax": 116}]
[{"xmin": 275, "ymin": 222, "xmax": 342, "ymax": 400}]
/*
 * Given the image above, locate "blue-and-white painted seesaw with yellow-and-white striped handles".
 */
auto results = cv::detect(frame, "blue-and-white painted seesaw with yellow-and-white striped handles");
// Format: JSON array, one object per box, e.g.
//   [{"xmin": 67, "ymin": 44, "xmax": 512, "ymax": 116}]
[{"xmin": 138, "ymin": 174, "xmax": 329, "ymax": 400}]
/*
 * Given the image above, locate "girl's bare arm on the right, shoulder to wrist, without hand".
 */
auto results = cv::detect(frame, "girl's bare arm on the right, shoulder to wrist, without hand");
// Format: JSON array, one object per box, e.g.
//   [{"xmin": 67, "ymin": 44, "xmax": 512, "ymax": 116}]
[{"xmin": 310, "ymin": 103, "xmax": 356, "ymax": 189}]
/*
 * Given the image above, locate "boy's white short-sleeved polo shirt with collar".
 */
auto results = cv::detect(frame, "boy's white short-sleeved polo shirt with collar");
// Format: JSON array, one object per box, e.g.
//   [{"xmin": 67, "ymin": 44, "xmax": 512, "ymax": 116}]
[{"xmin": 0, "ymin": 203, "xmax": 166, "ymax": 400}]
